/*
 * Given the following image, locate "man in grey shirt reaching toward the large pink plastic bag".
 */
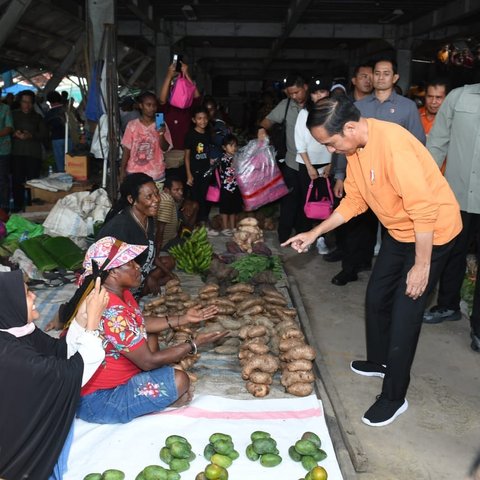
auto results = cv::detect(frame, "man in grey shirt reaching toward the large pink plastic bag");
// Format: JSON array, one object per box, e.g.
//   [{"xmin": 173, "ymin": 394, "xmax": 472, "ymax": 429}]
[{"xmin": 258, "ymin": 73, "xmax": 308, "ymax": 242}]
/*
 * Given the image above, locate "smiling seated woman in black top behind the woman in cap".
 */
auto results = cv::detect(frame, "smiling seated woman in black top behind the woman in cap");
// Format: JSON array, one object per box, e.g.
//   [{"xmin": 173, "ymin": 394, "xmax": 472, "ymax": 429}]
[{"xmin": 97, "ymin": 173, "xmax": 175, "ymax": 297}]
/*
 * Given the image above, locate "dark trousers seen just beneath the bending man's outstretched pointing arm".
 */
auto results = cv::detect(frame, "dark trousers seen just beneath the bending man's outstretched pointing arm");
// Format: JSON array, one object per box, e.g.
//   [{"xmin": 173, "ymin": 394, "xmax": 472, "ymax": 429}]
[{"xmin": 337, "ymin": 209, "xmax": 378, "ymax": 273}]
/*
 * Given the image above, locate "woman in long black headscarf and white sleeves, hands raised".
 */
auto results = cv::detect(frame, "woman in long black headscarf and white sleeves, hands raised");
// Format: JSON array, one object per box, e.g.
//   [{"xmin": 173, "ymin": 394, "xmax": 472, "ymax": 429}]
[{"xmin": 0, "ymin": 270, "xmax": 108, "ymax": 480}]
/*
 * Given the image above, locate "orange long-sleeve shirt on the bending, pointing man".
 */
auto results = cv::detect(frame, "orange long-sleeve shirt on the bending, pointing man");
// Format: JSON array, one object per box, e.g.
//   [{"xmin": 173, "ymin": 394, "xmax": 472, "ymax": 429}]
[{"xmin": 336, "ymin": 118, "xmax": 462, "ymax": 245}]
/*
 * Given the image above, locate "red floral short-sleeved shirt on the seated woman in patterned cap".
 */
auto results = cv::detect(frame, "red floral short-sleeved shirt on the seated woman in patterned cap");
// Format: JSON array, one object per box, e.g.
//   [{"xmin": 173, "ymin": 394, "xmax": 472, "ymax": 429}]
[{"xmin": 81, "ymin": 290, "xmax": 147, "ymax": 395}]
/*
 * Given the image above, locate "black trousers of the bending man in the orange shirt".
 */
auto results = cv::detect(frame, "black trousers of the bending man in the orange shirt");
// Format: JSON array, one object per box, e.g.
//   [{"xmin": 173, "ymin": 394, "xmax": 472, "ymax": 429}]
[{"xmin": 366, "ymin": 233, "xmax": 454, "ymax": 400}]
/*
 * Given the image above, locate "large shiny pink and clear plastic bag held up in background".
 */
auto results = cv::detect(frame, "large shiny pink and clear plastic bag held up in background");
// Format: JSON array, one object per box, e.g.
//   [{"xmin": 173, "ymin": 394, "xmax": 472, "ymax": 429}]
[{"xmin": 233, "ymin": 140, "xmax": 288, "ymax": 212}]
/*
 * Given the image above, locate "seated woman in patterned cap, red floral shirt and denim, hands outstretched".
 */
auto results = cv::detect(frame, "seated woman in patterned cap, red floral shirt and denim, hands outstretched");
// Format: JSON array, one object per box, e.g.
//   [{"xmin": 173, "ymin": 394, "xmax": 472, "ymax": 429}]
[{"xmin": 77, "ymin": 237, "xmax": 227, "ymax": 423}]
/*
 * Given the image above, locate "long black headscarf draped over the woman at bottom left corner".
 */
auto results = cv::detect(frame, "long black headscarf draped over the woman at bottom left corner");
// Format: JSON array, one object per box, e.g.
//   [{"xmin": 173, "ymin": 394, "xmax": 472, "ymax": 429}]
[{"xmin": 0, "ymin": 270, "xmax": 83, "ymax": 480}]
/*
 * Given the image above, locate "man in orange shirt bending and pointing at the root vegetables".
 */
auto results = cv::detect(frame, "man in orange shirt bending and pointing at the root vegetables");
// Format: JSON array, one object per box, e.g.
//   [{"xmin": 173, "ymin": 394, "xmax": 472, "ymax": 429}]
[{"xmin": 282, "ymin": 97, "xmax": 462, "ymax": 426}]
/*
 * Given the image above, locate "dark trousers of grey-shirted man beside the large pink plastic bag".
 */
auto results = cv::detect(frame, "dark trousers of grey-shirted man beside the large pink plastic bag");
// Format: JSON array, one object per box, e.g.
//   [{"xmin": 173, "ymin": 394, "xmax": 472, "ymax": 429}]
[{"xmin": 278, "ymin": 165, "xmax": 311, "ymax": 243}]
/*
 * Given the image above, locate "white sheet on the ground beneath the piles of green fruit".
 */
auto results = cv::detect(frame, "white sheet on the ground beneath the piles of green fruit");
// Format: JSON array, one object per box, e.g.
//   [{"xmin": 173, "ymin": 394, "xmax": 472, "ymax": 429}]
[{"xmin": 64, "ymin": 395, "xmax": 343, "ymax": 480}]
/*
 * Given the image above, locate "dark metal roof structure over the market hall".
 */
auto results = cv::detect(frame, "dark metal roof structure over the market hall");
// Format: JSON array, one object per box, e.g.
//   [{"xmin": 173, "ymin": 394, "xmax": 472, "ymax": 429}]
[{"xmin": 0, "ymin": 0, "xmax": 480, "ymax": 88}]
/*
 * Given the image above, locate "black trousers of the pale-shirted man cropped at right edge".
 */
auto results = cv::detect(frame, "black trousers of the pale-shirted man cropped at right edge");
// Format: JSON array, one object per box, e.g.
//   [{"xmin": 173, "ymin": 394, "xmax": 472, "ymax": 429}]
[{"xmin": 437, "ymin": 211, "xmax": 480, "ymax": 318}]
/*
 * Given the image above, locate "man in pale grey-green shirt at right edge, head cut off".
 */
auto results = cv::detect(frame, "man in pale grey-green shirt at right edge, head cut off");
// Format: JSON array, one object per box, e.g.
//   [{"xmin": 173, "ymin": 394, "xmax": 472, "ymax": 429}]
[{"xmin": 423, "ymin": 83, "xmax": 480, "ymax": 352}]
